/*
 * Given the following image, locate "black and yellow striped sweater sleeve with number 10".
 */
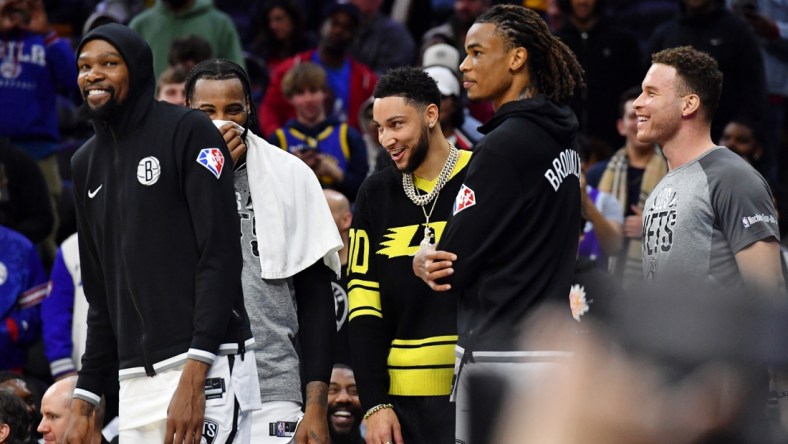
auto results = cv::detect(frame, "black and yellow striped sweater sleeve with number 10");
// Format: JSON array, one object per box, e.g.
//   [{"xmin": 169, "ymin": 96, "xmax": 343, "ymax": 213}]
[{"xmin": 348, "ymin": 183, "xmax": 391, "ymax": 410}]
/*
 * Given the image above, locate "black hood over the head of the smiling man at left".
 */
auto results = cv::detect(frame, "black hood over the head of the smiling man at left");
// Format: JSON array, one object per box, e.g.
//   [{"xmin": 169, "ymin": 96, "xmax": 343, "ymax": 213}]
[{"xmin": 77, "ymin": 23, "xmax": 156, "ymax": 102}]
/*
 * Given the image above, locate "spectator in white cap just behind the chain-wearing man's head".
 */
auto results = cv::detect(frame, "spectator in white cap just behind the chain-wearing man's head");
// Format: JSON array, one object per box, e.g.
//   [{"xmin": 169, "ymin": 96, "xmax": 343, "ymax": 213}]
[{"xmin": 424, "ymin": 66, "xmax": 478, "ymax": 150}]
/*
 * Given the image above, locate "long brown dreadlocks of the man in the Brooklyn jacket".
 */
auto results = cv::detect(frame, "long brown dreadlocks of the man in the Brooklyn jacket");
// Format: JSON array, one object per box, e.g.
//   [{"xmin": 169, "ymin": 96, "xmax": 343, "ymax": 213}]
[{"xmin": 475, "ymin": 5, "xmax": 585, "ymax": 103}]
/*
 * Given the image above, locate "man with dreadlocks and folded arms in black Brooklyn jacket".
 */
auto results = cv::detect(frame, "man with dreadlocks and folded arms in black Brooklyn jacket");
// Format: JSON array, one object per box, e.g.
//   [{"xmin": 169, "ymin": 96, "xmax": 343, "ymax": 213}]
[{"xmin": 413, "ymin": 5, "xmax": 583, "ymax": 442}]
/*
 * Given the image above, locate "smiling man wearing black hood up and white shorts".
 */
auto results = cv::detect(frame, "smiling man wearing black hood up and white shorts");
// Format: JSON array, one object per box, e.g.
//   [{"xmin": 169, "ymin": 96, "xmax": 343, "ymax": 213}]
[{"xmin": 67, "ymin": 24, "xmax": 260, "ymax": 444}]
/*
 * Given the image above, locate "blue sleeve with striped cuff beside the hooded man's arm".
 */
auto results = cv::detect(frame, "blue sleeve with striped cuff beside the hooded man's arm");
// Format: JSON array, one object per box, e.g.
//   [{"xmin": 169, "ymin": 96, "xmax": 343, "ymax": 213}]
[{"xmin": 41, "ymin": 249, "xmax": 76, "ymax": 378}]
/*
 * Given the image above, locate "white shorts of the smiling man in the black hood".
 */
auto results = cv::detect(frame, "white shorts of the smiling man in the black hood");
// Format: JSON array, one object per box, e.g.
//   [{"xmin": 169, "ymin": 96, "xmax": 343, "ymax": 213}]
[{"xmin": 118, "ymin": 350, "xmax": 260, "ymax": 444}]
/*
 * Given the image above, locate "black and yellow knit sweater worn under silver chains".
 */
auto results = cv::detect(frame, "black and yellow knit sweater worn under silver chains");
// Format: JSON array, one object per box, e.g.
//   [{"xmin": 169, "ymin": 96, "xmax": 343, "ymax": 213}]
[{"xmin": 348, "ymin": 151, "xmax": 471, "ymax": 409}]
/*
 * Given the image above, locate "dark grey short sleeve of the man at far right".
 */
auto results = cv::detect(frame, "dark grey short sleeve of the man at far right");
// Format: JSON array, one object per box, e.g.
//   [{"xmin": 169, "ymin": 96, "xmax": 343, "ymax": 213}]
[{"xmin": 712, "ymin": 168, "xmax": 780, "ymax": 254}]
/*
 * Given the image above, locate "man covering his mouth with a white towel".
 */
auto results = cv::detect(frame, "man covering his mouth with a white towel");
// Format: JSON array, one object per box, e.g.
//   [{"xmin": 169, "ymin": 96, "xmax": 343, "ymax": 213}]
[{"xmin": 186, "ymin": 59, "xmax": 343, "ymax": 444}]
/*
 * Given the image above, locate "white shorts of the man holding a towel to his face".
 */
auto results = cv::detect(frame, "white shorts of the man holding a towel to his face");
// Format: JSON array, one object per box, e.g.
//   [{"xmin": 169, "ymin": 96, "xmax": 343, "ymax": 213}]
[{"xmin": 252, "ymin": 401, "xmax": 304, "ymax": 444}]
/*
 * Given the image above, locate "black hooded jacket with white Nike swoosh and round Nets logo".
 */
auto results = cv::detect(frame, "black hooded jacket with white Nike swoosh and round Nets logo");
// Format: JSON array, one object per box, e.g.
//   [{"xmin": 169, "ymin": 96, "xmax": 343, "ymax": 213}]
[{"xmin": 71, "ymin": 24, "xmax": 251, "ymax": 403}]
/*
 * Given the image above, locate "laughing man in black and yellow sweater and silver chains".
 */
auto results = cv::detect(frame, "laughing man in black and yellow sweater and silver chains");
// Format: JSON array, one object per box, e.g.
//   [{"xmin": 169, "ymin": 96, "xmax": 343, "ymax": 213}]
[{"xmin": 348, "ymin": 67, "xmax": 471, "ymax": 444}]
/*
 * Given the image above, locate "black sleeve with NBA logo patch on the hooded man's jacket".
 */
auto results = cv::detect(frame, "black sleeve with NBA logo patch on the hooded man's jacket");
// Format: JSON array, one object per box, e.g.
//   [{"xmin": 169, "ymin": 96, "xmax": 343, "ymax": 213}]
[{"xmin": 175, "ymin": 111, "xmax": 242, "ymax": 364}]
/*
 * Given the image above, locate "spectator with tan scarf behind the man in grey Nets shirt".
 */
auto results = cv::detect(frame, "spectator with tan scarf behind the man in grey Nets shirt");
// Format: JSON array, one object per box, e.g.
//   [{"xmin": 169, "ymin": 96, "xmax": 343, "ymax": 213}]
[{"xmin": 589, "ymin": 87, "xmax": 668, "ymax": 288}]
